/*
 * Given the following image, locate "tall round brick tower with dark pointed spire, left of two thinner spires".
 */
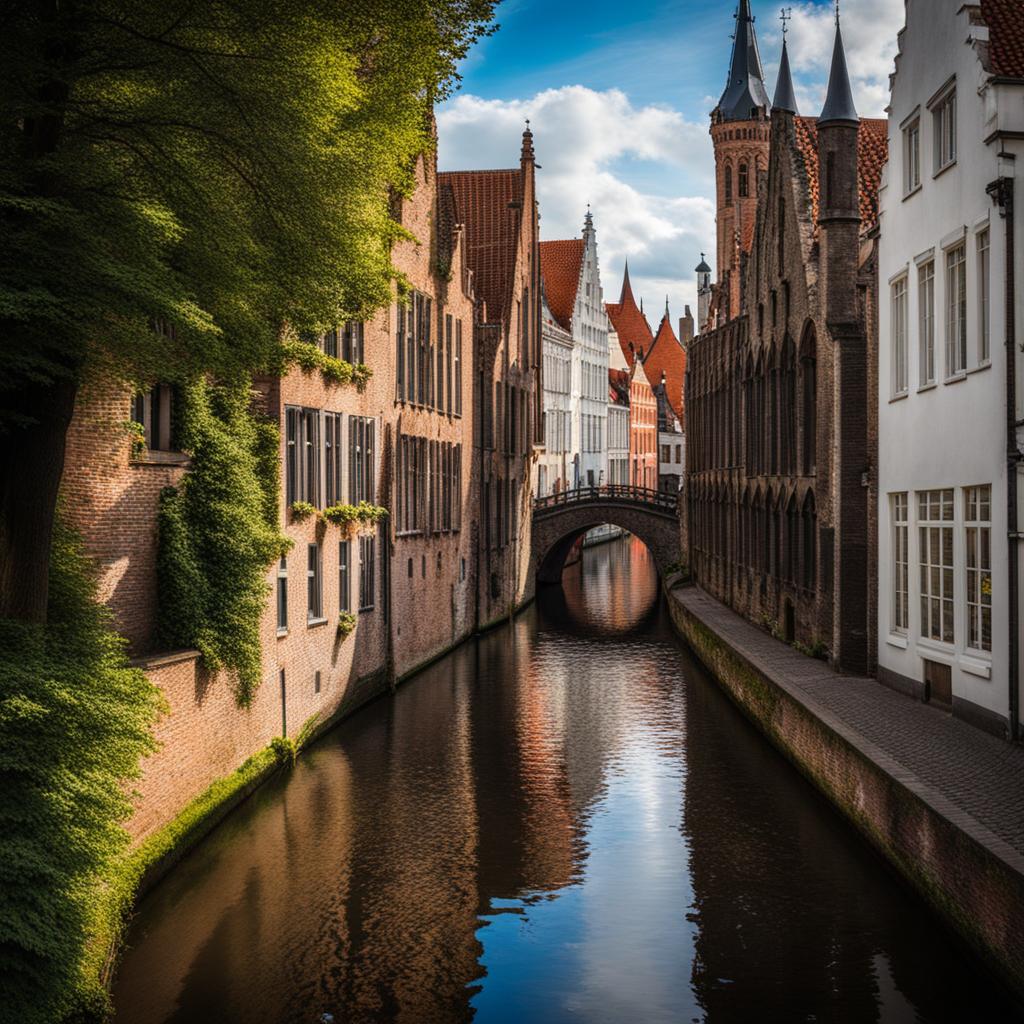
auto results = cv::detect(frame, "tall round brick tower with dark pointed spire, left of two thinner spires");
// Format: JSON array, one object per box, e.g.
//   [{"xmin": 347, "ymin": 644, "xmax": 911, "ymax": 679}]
[{"xmin": 711, "ymin": 0, "xmax": 771, "ymax": 319}]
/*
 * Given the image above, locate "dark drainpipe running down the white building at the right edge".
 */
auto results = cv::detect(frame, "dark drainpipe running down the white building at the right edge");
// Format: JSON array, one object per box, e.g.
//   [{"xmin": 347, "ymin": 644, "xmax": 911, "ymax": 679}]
[{"xmin": 985, "ymin": 153, "xmax": 1021, "ymax": 739}]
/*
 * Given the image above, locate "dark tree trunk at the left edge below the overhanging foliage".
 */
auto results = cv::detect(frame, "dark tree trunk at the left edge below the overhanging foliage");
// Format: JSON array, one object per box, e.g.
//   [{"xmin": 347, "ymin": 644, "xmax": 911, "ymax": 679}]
[{"xmin": 0, "ymin": 380, "xmax": 78, "ymax": 623}]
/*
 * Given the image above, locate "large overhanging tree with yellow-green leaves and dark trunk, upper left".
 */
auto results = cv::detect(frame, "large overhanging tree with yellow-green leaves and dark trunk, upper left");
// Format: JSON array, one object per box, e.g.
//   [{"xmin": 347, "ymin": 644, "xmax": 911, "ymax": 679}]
[{"xmin": 0, "ymin": 0, "xmax": 494, "ymax": 617}]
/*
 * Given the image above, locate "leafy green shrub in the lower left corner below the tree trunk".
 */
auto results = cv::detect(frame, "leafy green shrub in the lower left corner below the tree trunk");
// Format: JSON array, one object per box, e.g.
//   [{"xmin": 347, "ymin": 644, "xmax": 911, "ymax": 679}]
[{"xmin": 0, "ymin": 518, "xmax": 161, "ymax": 1024}]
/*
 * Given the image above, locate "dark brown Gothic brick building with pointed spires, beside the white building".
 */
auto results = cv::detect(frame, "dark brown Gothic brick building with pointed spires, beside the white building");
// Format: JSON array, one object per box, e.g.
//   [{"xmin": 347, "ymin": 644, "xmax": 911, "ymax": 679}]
[{"xmin": 683, "ymin": 16, "xmax": 886, "ymax": 672}]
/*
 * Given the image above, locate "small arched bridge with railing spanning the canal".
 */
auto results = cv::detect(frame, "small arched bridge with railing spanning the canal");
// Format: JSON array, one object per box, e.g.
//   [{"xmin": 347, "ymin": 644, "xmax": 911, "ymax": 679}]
[{"xmin": 532, "ymin": 484, "xmax": 680, "ymax": 583}]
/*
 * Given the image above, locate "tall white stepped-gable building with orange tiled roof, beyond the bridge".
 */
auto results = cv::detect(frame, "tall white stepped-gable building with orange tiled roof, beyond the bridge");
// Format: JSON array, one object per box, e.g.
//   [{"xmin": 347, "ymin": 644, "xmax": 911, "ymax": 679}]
[{"xmin": 541, "ymin": 210, "xmax": 608, "ymax": 487}]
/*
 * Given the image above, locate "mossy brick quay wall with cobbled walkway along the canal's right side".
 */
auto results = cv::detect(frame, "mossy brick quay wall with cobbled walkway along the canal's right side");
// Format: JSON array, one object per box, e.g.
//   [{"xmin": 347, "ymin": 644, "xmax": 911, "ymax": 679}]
[{"xmin": 668, "ymin": 586, "xmax": 1024, "ymax": 997}]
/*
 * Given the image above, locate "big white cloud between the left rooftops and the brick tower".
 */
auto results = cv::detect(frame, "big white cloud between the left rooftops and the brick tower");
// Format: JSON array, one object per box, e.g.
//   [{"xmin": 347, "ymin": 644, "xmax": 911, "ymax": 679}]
[{"xmin": 437, "ymin": 85, "xmax": 715, "ymax": 321}]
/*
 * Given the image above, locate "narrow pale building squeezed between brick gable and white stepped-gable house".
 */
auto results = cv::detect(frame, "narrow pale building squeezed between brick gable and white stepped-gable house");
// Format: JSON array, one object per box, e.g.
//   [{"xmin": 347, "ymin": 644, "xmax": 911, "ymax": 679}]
[{"xmin": 535, "ymin": 288, "xmax": 574, "ymax": 498}]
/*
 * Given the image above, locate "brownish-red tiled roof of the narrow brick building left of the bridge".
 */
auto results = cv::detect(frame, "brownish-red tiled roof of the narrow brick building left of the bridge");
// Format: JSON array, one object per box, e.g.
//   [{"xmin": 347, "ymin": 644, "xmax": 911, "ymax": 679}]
[{"xmin": 437, "ymin": 168, "xmax": 522, "ymax": 323}]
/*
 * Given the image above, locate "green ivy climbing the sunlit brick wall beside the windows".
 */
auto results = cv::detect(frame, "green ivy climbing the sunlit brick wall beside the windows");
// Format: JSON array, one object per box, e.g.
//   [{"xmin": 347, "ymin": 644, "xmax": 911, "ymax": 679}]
[{"xmin": 157, "ymin": 379, "xmax": 286, "ymax": 705}]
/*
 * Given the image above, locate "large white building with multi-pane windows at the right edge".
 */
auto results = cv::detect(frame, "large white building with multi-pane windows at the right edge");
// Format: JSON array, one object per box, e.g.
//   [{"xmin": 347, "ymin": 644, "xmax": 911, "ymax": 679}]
[{"xmin": 878, "ymin": 0, "xmax": 1024, "ymax": 734}]
